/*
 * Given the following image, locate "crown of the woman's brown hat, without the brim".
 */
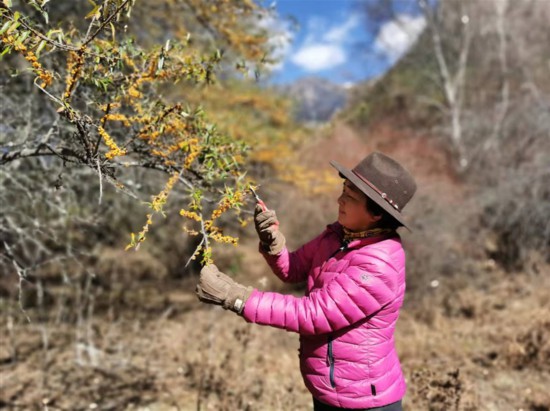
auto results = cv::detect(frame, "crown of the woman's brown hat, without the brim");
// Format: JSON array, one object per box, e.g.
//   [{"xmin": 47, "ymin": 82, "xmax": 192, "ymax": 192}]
[{"xmin": 352, "ymin": 152, "xmax": 416, "ymax": 212}]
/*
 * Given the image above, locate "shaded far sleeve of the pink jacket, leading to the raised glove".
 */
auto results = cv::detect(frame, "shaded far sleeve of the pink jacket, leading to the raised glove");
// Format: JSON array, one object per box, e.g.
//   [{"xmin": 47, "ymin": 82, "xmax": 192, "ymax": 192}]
[{"xmin": 260, "ymin": 231, "xmax": 326, "ymax": 283}]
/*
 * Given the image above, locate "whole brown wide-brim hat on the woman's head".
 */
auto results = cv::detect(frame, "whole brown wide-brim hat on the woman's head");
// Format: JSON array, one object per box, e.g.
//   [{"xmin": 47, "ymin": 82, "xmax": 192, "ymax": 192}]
[{"xmin": 330, "ymin": 152, "xmax": 416, "ymax": 228}]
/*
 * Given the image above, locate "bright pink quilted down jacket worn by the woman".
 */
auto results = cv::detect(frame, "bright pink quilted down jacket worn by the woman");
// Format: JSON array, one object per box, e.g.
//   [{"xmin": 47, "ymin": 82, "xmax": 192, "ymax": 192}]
[{"xmin": 243, "ymin": 223, "xmax": 406, "ymax": 408}]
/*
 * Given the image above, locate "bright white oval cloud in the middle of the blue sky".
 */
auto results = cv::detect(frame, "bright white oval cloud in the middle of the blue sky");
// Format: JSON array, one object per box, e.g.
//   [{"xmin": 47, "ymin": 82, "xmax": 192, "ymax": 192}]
[{"xmin": 291, "ymin": 43, "xmax": 346, "ymax": 72}]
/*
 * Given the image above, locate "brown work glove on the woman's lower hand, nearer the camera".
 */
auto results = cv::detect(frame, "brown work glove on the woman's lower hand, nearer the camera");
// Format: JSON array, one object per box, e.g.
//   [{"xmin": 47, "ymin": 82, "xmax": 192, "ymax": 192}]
[{"xmin": 195, "ymin": 264, "xmax": 252, "ymax": 314}]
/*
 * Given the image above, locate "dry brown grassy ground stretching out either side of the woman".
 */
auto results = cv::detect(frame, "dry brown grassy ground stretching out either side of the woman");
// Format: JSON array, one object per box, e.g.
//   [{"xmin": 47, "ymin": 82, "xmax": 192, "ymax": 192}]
[{"xmin": 0, "ymin": 245, "xmax": 550, "ymax": 411}]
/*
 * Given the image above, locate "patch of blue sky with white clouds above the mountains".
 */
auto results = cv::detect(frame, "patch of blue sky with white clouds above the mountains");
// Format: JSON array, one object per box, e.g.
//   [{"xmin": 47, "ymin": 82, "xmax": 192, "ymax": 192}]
[{"xmin": 269, "ymin": 0, "xmax": 425, "ymax": 84}]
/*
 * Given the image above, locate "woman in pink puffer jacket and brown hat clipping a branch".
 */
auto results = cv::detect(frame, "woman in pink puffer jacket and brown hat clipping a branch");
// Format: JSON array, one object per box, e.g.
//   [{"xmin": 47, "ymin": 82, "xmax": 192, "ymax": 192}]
[{"xmin": 197, "ymin": 152, "xmax": 416, "ymax": 411}]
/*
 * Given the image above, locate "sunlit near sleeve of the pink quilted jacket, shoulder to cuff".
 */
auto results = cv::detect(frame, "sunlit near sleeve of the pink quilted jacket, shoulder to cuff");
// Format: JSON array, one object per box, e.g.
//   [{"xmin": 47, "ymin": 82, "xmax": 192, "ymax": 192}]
[{"xmin": 243, "ymin": 253, "xmax": 398, "ymax": 335}]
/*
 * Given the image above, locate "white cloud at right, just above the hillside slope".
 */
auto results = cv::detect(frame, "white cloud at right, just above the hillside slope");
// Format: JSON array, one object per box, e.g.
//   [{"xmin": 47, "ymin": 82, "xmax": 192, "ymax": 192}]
[{"xmin": 374, "ymin": 14, "xmax": 426, "ymax": 63}]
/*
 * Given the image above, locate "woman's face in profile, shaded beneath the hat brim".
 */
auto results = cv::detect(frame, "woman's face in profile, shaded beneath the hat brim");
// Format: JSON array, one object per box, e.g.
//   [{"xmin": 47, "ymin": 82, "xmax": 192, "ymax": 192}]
[{"xmin": 338, "ymin": 180, "xmax": 381, "ymax": 231}]
